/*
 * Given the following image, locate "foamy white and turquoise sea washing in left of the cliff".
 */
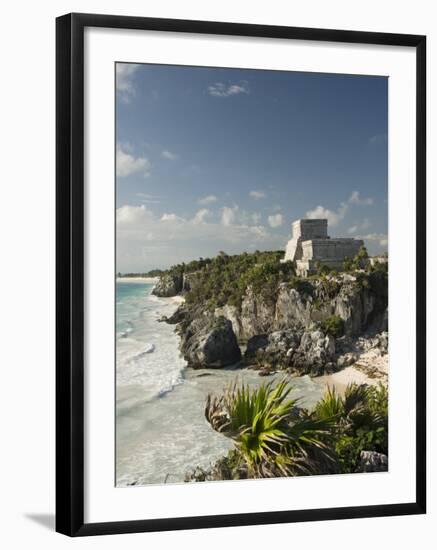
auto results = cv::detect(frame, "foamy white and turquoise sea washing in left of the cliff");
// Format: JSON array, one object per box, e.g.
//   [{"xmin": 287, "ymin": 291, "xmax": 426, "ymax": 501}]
[{"xmin": 116, "ymin": 281, "xmax": 323, "ymax": 487}]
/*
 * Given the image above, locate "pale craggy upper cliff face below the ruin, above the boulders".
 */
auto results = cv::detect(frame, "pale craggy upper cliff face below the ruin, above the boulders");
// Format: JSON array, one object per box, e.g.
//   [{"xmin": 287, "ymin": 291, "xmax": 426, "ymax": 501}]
[{"xmin": 211, "ymin": 273, "xmax": 387, "ymax": 343}]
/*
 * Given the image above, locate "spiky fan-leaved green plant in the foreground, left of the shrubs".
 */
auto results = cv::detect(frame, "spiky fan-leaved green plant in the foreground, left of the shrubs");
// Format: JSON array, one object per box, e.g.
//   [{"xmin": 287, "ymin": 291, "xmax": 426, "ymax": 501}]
[{"xmin": 205, "ymin": 380, "xmax": 330, "ymax": 477}]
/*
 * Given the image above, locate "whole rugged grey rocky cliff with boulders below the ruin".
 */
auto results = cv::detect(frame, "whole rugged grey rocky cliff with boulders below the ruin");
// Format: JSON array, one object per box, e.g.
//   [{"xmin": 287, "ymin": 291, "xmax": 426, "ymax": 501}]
[{"xmin": 153, "ymin": 254, "xmax": 388, "ymax": 375}]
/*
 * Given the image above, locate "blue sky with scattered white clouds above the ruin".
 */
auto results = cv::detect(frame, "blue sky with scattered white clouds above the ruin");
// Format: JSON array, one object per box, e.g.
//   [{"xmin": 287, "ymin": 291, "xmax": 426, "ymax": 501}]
[{"xmin": 115, "ymin": 63, "xmax": 388, "ymax": 273}]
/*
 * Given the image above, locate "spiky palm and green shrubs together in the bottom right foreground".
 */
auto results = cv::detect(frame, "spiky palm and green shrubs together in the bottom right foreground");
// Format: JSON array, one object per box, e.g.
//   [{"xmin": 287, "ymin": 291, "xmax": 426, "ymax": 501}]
[{"xmin": 200, "ymin": 380, "xmax": 388, "ymax": 481}]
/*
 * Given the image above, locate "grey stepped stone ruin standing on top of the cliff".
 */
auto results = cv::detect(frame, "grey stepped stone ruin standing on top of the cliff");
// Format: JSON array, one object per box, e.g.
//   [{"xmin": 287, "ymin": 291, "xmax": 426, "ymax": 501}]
[{"xmin": 281, "ymin": 219, "xmax": 364, "ymax": 277}]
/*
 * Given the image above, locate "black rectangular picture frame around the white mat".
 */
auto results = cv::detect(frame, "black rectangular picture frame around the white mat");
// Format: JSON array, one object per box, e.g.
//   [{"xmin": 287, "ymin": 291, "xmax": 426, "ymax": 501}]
[{"xmin": 56, "ymin": 13, "xmax": 426, "ymax": 536}]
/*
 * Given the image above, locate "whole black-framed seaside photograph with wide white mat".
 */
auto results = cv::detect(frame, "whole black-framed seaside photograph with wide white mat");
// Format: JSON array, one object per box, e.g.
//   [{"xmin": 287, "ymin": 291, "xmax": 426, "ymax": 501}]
[{"xmin": 56, "ymin": 14, "xmax": 426, "ymax": 536}]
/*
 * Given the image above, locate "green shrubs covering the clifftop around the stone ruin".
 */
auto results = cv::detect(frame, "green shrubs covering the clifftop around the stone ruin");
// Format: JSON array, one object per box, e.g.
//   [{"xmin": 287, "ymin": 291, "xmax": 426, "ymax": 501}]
[{"xmin": 152, "ymin": 247, "xmax": 387, "ymax": 320}]
